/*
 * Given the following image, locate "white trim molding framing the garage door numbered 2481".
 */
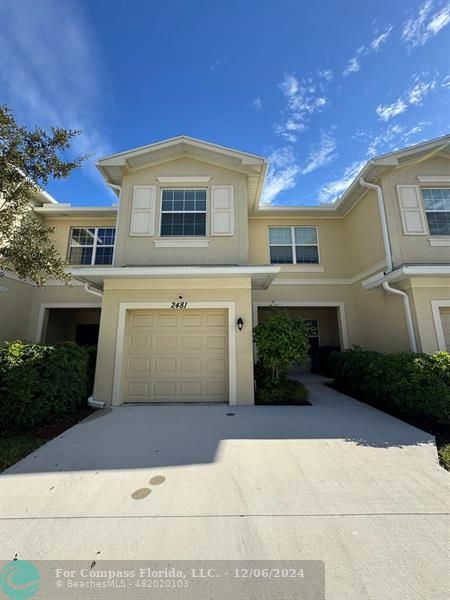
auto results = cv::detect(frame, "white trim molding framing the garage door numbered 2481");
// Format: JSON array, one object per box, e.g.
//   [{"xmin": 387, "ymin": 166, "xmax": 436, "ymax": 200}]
[{"xmin": 112, "ymin": 301, "xmax": 237, "ymax": 406}]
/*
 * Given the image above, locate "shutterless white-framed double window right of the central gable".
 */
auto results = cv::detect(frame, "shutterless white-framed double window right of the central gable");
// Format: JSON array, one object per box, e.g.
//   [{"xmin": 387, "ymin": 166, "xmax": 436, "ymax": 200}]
[{"xmin": 269, "ymin": 227, "xmax": 319, "ymax": 265}]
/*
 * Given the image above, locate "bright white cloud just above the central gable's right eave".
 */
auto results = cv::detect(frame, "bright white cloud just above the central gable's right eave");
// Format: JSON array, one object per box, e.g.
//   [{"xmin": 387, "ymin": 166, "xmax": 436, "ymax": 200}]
[{"xmin": 261, "ymin": 146, "xmax": 301, "ymax": 204}]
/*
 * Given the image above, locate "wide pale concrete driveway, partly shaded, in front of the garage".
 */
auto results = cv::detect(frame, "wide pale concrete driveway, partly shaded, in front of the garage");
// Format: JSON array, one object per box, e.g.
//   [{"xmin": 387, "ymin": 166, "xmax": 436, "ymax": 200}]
[{"xmin": 0, "ymin": 383, "xmax": 450, "ymax": 600}]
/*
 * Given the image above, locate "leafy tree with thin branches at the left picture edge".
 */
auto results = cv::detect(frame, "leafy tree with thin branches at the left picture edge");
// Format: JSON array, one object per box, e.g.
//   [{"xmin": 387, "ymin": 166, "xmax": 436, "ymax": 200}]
[{"xmin": 0, "ymin": 105, "xmax": 86, "ymax": 286}]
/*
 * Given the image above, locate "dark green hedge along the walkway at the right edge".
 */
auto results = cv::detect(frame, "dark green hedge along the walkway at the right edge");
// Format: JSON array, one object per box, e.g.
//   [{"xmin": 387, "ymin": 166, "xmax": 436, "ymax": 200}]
[{"xmin": 329, "ymin": 349, "xmax": 450, "ymax": 427}]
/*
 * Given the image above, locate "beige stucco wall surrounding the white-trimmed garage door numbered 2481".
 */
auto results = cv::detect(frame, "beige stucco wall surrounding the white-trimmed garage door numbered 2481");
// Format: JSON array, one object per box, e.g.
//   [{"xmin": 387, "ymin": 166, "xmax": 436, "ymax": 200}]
[{"xmin": 94, "ymin": 278, "xmax": 253, "ymax": 404}]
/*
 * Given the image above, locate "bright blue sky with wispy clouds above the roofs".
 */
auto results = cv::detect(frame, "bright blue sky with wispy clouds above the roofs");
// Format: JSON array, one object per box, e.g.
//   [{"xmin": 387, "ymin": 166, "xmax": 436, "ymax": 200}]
[{"xmin": 0, "ymin": 0, "xmax": 450, "ymax": 205}]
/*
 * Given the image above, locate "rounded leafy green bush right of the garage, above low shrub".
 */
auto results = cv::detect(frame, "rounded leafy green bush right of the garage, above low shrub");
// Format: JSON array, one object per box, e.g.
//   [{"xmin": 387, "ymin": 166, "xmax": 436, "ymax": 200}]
[{"xmin": 253, "ymin": 310, "xmax": 312, "ymax": 381}]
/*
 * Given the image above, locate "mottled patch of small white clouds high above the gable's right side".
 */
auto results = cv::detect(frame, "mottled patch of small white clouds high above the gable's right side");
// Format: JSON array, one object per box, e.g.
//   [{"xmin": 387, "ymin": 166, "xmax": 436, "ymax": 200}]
[{"xmin": 275, "ymin": 73, "xmax": 328, "ymax": 143}]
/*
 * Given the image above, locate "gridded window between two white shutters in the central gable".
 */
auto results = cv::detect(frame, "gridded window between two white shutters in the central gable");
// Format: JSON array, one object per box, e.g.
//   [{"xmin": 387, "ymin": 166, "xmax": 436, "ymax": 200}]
[{"xmin": 161, "ymin": 189, "xmax": 206, "ymax": 236}]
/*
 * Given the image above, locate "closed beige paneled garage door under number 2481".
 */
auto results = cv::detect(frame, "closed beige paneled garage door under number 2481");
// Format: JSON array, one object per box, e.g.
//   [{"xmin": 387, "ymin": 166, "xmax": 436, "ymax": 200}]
[{"xmin": 124, "ymin": 309, "xmax": 228, "ymax": 402}]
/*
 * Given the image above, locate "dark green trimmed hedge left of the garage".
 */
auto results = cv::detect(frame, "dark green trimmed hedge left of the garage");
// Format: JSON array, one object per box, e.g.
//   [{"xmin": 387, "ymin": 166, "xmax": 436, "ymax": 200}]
[{"xmin": 0, "ymin": 341, "xmax": 92, "ymax": 431}]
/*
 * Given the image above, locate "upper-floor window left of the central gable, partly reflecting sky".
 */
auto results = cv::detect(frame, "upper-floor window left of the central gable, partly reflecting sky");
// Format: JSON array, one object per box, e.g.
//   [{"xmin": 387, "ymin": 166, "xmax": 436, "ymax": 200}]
[{"xmin": 68, "ymin": 227, "xmax": 116, "ymax": 265}]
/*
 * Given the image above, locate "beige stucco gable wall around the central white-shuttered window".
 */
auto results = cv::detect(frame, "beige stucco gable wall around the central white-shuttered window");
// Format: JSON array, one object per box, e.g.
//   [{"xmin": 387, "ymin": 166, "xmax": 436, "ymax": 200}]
[{"xmin": 115, "ymin": 158, "xmax": 248, "ymax": 266}]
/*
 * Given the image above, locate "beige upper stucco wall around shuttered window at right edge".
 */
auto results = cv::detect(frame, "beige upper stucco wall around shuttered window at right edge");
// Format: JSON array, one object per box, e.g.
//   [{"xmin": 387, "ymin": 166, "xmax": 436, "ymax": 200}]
[{"xmin": 381, "ymin": 157, "xmax": 450, "ymax": 266}]
